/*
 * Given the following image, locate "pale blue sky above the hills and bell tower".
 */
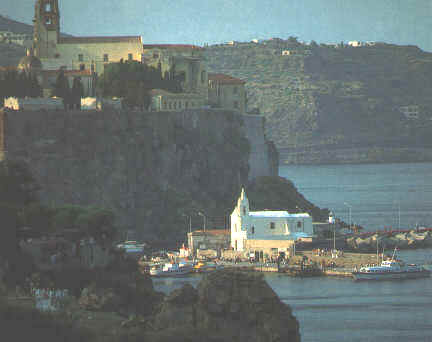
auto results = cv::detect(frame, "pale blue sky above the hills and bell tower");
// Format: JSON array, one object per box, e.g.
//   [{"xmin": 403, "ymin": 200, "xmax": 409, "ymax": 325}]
[{"xmin": 0, "ymin": 0, "xmax": 432, "ymax": 51}]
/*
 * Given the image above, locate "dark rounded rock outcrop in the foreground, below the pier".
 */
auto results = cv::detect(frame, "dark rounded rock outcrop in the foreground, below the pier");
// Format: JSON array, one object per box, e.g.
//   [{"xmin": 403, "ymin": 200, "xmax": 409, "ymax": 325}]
[{"xmin": 152, "ymin": 270, "xmax": 300, "ymax": 342}]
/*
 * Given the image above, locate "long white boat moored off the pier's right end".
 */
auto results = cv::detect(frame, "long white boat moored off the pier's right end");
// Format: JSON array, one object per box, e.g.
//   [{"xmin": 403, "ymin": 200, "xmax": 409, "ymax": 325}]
[{"xmin": 352, "ymin": 257, "xmax": 431, "ymax": 280}]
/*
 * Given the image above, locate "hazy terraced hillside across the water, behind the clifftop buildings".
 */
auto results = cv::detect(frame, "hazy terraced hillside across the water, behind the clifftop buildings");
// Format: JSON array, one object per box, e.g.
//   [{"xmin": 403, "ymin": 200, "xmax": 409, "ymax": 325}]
[{"xmin": 206, "ymin": 38, "xmax": 432, "ymax": 162}]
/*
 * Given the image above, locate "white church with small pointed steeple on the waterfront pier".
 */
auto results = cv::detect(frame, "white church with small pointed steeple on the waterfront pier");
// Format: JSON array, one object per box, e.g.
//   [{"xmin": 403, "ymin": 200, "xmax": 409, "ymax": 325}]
[{"xmin": 231, "ymin": 189, "xmax": 313, "ymax": 255}]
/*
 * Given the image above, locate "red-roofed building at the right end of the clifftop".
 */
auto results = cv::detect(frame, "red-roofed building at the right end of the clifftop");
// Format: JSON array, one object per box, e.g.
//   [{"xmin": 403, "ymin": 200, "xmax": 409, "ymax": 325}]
[{"xmin": 208, "ymin": 73, "xmax": 246, "ymax": 113}]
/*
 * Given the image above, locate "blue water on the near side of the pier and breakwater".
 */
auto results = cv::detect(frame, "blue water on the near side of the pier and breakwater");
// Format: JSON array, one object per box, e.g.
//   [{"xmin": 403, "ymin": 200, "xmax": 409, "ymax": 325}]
[{"xmin": 153, "ymin": 250, "xmax": 432, "ymax": 342}]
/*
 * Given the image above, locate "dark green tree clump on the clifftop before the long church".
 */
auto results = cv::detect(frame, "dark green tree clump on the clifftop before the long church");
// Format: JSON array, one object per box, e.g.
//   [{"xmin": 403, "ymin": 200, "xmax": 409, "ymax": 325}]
[{"xmin": 98, "ymin": 61, "xmax": 182, "ymax": 108}]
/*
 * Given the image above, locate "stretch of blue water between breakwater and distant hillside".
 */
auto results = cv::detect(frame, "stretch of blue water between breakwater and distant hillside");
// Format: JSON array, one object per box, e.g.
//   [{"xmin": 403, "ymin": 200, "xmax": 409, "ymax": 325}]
[{"xmin": 279, "ymin": 163, "xmax": 432, "ymax": 230}]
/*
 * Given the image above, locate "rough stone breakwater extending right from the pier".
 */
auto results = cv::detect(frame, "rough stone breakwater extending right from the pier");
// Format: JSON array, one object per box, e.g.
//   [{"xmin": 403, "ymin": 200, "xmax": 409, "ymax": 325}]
[{"xmin": 346, "ymin": 230, "xmax": 432, "ymax": 251}]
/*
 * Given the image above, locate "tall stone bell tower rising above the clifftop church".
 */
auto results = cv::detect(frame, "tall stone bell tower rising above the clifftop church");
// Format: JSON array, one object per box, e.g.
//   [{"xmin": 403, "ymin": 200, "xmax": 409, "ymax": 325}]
[{"xmin": 33, "ymin": 0, "xmax": 60, "ymax": 58}]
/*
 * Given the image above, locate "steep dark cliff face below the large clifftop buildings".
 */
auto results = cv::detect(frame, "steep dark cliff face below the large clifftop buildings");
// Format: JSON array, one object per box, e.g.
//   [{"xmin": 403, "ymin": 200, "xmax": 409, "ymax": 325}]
[{"xmin": 0, "ymin": 110, "xmax": 270, "ymax": 236}]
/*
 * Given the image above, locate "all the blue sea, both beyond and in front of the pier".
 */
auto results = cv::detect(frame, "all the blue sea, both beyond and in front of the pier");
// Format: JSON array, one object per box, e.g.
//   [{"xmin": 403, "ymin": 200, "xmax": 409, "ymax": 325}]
[{"xmin": 154, "ymin": 163, "xmax": 432, "ymax": 342}]
